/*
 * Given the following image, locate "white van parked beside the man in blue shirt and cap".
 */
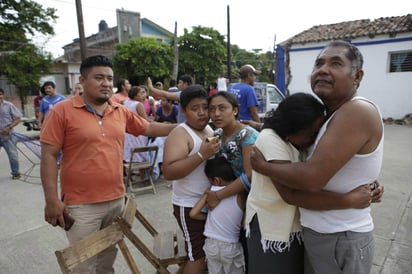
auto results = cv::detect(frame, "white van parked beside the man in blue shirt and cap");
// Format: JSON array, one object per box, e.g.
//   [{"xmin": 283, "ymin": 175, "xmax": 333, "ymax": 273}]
[{"xmin": 254, "ymin": 82, "xmax": 285, "ymax": 119}]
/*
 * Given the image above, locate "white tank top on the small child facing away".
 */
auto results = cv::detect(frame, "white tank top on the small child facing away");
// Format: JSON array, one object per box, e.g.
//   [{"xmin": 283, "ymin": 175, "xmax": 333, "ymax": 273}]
[{"xmin": 203, "ymin": 186, "xmax": 243, "ymax": 243}]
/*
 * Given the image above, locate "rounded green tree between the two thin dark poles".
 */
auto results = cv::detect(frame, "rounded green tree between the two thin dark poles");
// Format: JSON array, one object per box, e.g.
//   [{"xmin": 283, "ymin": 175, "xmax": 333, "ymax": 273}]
[{"xmin": 178, "ymin": 26, "xmax": 226, "ymax": 85}]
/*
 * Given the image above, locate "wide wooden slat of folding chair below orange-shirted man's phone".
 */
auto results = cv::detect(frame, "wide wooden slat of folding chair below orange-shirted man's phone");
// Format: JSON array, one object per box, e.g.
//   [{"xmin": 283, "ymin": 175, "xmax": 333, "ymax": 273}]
[{"xmin": 55, "ymin": 223, "xmax": 123, "ymax": 273}]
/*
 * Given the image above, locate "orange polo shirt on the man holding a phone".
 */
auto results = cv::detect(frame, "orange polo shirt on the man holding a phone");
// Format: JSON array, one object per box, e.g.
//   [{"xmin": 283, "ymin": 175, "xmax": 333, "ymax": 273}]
[{"xmin": 40, "ymin": 96, "xmax": 148, "ymax": 205}]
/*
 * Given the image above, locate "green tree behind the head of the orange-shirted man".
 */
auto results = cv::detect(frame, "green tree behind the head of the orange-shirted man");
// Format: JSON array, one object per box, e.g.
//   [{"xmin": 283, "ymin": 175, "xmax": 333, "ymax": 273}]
[{"xmin": 112, "ymin": 37, "xmax": 173, "ymax": 84}]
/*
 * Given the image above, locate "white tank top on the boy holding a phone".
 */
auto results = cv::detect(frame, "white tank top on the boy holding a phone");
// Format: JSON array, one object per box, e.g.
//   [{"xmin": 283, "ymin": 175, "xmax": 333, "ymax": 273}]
[{"xmin": 172, "ymin": 123, "xmax": 213, "ymax": 207}]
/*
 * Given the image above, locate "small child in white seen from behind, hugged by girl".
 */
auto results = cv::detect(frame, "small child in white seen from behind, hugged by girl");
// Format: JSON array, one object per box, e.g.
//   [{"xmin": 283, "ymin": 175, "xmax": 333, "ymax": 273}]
[{"xmin": 190, "ymin": 156, "xmax": 246, "ymax": 274}]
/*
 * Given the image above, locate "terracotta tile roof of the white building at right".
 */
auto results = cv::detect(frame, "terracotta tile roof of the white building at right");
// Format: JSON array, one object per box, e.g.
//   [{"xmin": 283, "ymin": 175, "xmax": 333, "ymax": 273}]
[{"xmin": 282, "ymin": 14, "xmax": 412, "ymax": 44}]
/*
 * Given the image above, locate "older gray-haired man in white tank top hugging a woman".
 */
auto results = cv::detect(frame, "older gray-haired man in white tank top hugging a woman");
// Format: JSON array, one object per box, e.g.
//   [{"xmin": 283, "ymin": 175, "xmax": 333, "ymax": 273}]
[{"xmin": 252, "ymin": 41, "xmax": 384, "ymax": 274}]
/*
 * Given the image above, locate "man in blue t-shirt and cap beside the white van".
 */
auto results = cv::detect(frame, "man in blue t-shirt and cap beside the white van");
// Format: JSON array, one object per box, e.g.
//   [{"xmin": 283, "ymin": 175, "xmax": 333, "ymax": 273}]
[{"xmin": 229, "ymin": 65, "xmax": 260, "ymax": 122}]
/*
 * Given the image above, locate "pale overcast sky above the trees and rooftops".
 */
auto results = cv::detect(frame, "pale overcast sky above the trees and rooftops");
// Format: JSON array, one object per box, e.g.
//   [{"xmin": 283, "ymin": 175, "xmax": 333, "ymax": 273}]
[{"xmin": 35, "ymin": 0, "xmax": 412, "ymax": 57}]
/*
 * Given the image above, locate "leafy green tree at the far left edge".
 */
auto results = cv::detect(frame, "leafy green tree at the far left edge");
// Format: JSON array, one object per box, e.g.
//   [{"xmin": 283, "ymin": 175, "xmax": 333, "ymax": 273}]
[{"xmin": 0, "ymin": 0, "xmax": 57, "ymax": 104}]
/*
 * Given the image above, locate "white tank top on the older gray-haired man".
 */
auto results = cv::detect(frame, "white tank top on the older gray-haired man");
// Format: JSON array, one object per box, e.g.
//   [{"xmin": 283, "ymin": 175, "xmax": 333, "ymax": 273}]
[{"xmin": 300, "ymin": 97, "xmax": 383, "ymax": 233}]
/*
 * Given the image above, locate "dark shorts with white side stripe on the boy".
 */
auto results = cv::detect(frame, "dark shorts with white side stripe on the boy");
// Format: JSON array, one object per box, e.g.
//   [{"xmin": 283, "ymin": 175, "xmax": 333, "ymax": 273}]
[{"xmin": 173, "ymin": 205, "xmax": 206, "ymax": 261}]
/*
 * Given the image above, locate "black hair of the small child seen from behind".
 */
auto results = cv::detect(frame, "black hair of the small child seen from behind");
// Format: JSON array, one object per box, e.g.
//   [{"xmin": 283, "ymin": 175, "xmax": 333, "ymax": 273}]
[{"xmin": 205, "ymin": 156, "xmax": 236, "ymax": 182}]
